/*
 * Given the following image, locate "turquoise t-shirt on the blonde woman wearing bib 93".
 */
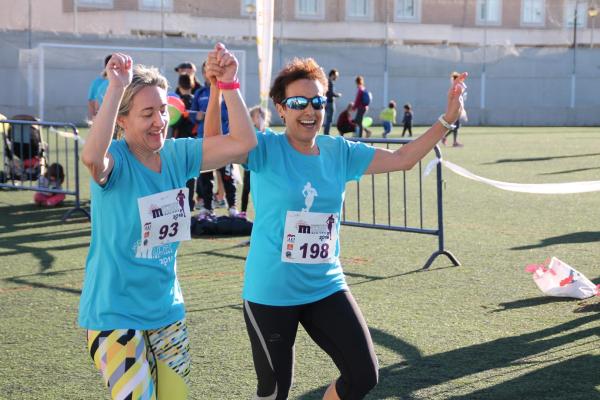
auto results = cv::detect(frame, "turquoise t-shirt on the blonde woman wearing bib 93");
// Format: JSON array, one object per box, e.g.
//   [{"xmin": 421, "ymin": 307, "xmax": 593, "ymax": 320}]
[{"xmin": 79, "ymin": 138, "xmax": 202, "ymax": 330}]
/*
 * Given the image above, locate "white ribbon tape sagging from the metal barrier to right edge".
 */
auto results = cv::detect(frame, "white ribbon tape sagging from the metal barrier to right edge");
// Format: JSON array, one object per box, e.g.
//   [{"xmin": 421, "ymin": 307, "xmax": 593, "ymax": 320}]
[{"xmin": 423, "ymin": 158, "xmax": 600, "ymax": 194}]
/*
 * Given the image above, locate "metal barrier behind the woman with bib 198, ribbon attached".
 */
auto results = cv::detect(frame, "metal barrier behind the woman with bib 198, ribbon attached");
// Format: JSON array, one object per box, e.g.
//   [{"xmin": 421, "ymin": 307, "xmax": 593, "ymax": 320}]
[{"xmin": 341, "ymin": 138, "xmax": 460, "ymax": 269}]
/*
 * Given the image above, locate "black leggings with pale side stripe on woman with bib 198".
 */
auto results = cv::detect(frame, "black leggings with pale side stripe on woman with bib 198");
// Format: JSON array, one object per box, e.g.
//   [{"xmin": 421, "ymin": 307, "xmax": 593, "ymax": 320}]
[{"xmin": 244, "ymin": 291, "xmax": 379, "ymax": 400}]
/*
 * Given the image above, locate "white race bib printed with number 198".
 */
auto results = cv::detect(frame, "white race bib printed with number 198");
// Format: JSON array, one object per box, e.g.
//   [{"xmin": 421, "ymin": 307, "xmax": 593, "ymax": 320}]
[{"xmin": 281, "ymin": 211, "xmax": 339, "ymax": 264}]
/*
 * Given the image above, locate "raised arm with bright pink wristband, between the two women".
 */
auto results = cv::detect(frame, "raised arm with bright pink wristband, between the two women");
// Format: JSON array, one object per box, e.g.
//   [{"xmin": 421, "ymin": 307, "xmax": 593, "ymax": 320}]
[{"xmin": 202, "ymin": 43, "xmax": 257, "ymax": 170}]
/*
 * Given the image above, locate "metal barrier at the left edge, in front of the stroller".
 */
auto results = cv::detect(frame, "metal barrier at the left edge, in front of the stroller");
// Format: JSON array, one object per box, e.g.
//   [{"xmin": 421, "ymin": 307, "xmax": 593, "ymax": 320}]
[{"xmin": 0, "ymin": 115, "xmax": 90, "ymax": 221}]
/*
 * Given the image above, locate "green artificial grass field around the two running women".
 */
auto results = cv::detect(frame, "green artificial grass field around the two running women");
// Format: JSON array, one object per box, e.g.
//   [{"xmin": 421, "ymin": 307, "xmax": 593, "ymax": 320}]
[{"xmin": 0, "ymin": 127, "xmax": 600, "ymax": 400}]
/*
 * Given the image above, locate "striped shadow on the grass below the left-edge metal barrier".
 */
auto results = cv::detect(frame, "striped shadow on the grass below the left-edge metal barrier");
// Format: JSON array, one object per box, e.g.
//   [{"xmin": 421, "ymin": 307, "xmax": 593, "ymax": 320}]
[{"xmin": 0, "ymin": 202, "xmax": 90, "ymax": 272}]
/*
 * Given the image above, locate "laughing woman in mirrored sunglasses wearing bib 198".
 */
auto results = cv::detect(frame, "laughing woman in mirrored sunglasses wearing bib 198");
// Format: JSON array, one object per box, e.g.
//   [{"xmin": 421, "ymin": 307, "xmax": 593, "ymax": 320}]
[{"xmin": 218, "ymin": 58, "xmax": 466, "ymax": 400}]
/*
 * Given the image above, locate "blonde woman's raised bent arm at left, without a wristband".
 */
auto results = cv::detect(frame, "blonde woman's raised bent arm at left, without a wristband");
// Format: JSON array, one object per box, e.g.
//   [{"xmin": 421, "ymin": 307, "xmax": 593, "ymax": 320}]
[{"xmin": 81, "ymin": 53, "xmax": 133, "ymax": 185}]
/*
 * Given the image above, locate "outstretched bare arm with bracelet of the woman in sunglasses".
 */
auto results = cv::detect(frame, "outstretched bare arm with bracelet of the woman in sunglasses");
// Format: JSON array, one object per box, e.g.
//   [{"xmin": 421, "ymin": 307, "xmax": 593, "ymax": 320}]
[{"xmin": 365, "ymin": 72, "xmax": 467, "ymax": 174}]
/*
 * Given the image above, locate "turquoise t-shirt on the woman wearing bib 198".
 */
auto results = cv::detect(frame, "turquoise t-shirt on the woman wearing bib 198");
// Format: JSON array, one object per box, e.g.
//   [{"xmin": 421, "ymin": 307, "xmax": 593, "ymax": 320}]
[{"xmin": 243, "ymin": 130, "xmax": 375, "ymax": 306}]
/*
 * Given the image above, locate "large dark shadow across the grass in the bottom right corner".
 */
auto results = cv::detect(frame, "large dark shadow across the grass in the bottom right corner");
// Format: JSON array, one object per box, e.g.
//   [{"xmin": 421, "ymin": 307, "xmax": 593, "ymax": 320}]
[{"xmin": 299, "ymin": 313, "xmax": 600, "ymax": 400}]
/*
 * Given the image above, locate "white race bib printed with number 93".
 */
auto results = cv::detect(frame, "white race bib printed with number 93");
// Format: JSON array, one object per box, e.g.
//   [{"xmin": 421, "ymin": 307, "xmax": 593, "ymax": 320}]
[{"xmin": 138, "ymin": 188, "xmax": 191, "ymax": 248}]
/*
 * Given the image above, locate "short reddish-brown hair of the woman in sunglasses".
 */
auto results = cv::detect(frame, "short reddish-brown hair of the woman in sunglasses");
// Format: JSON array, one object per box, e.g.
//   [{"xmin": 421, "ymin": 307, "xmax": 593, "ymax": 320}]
[{"xmin": 269, "ymin": 57, "xmax": 327, "ymax": 104}]
